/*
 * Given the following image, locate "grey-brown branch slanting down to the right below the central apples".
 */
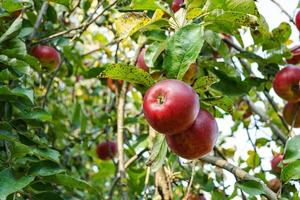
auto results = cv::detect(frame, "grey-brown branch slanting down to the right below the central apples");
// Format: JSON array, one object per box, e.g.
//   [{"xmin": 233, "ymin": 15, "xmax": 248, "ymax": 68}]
[{"xmin": 200, "ymin": 156, "xmax": 278, "ymax": 200}]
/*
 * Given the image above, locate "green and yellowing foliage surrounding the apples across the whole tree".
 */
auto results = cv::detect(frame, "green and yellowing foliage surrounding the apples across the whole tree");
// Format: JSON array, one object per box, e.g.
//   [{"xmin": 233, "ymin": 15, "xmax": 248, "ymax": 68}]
[{"xmin": 0, "ymin": 0, "xmax": 300, "ymax": 200}]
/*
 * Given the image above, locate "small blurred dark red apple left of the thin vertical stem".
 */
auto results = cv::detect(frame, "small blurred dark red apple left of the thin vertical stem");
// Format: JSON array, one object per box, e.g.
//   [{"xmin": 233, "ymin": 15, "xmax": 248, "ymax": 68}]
[{"xmin": 96, "ymin": 141, "xmax": 117, "ymax": 160}]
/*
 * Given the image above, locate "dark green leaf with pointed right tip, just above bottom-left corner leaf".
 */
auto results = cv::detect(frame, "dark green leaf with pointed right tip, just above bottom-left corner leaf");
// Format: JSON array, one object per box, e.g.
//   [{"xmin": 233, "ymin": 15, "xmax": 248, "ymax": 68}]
[{"xmin": 29, "ymin": 160, "xmax": 64, "ymax": 176}]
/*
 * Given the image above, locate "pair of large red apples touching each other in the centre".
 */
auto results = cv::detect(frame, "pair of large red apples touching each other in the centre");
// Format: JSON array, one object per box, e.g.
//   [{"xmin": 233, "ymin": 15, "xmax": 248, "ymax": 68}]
[{"xmin": 143, "ymin": 79, "xmax": 218, "ymax": 159}]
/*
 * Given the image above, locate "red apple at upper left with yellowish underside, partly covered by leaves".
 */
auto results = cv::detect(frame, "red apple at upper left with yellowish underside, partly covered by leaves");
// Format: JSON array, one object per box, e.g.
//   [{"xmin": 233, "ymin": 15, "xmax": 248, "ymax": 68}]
[{"xmin": 31, "ymin": 45, "xmax": 61, "ymax": 72}]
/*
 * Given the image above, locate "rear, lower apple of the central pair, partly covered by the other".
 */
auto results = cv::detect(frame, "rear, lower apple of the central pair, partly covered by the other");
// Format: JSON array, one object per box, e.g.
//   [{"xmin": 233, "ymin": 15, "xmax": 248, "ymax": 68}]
[{"xmin": 166, "ymin": 109, "xmax": 218, "ymax": 160}]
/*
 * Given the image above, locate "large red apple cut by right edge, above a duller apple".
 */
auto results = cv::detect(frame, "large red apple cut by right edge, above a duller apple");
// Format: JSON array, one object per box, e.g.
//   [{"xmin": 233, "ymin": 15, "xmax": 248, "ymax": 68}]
[{"xmin": 273, "ymin": 65, "xmax": 300, "ymax": 102}]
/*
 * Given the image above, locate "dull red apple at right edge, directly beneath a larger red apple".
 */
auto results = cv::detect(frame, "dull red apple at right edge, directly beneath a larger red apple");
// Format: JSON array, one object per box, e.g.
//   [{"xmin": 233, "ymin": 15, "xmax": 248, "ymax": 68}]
[{"xmin": 283, "ymin": 103, "xmax": 300, "ymax": 128}]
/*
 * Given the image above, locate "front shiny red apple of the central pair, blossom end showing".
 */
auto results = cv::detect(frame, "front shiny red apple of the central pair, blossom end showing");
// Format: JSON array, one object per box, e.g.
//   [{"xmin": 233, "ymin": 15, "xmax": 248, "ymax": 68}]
[{"xmin": 143, "ymin": 79, "xmax": 200, "ymax": 135}]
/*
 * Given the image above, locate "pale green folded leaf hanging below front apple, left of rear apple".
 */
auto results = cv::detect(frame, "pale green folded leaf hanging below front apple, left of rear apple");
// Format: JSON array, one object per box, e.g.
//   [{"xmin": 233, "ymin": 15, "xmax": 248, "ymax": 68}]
[{"xmin": 146, "ymin": 134, "xmax": 168, "ymax": 172}]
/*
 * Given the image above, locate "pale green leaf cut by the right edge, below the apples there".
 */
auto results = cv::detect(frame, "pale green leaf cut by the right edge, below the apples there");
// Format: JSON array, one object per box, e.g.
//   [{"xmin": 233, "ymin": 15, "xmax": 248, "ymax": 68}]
[{"xmin": 283, "ymin": 135, "xmax": 300, "ymax": 163}]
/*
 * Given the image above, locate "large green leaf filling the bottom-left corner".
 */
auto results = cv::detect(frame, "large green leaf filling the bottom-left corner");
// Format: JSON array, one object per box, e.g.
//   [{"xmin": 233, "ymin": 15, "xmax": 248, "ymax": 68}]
[{"xmin": 0, "ymin": 168, "xmax": 34, "ymax": 200}]
